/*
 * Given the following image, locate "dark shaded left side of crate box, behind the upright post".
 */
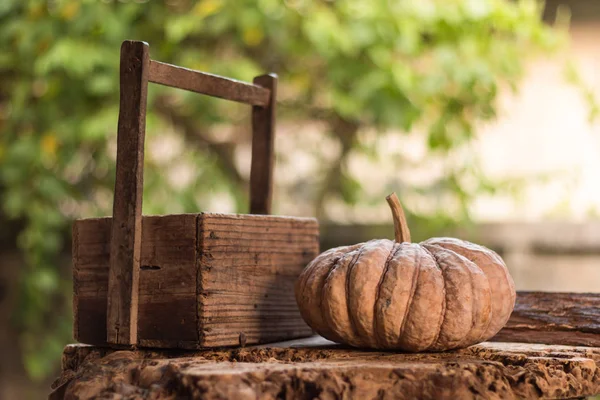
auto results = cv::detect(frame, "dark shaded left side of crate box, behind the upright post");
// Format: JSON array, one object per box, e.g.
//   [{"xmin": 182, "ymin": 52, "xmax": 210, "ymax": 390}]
[{"xmin": 73, "ymin": 214, "xmax": 198, "ymax": 347}]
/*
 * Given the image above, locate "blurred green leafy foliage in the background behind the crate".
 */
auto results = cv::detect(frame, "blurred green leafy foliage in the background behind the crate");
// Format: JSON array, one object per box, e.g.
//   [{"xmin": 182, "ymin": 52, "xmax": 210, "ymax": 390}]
[{"xmin": 0, "ymin": 0, "xmax": 561, "ymax": 378}]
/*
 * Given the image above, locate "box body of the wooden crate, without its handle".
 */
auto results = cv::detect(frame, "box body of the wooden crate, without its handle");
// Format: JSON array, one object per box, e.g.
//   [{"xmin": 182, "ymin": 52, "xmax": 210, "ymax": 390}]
[{"xmin": 73, "ymin": 213, "xmax": 319, "ymax": 348}]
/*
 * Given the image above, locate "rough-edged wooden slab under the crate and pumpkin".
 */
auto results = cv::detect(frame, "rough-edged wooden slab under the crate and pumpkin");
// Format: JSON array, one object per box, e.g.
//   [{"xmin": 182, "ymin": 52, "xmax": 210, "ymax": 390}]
[{"xmin": 50, "ymin": 336, "xmax": 600, "ymax": 400}]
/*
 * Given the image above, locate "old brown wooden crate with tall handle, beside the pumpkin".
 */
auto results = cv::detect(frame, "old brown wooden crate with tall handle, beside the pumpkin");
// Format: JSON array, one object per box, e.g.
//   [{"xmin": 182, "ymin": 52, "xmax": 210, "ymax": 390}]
[{"xmin": 73, "ymin": 41, "xmax": 319, "ymax": 348}]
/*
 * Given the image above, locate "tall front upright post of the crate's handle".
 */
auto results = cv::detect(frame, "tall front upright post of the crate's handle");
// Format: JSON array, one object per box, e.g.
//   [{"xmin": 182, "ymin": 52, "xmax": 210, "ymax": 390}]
[{"xmin": 106, "ymin": 41, "xmax": 150, "ymax": 345}]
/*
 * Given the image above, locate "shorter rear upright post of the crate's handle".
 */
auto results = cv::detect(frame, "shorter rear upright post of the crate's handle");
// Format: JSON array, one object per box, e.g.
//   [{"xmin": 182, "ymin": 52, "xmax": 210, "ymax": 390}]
[{"xmin": 250, "ymin": 74, "xmax": 277, "ymax": 214}]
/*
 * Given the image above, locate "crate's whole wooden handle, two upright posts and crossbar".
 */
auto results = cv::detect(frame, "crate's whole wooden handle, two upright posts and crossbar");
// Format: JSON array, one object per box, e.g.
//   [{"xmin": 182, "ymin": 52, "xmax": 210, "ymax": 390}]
[{"xmin": 106, "ymin": 40, "xmax": 277, "ymax": 345}]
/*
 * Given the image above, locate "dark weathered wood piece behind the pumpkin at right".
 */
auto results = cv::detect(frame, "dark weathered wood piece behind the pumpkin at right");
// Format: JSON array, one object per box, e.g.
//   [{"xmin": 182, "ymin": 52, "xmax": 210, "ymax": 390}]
[{"xmin": 492, "ymin": 292, "xmax": 600, "ymax": 347}]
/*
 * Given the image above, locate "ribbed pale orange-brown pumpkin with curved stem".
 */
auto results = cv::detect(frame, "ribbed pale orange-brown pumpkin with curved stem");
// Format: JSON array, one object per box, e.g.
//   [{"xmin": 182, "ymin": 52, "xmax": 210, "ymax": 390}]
[{"xmin": 295, "ymin": 193, "xmax": 516, "ymax": 352}]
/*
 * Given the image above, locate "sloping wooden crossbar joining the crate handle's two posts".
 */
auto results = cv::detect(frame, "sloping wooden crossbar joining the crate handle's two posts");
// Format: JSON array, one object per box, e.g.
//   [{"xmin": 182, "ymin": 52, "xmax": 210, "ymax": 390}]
[{"xmin": 149, "ymin": 60, "xmax": 271, "ymax": 106}]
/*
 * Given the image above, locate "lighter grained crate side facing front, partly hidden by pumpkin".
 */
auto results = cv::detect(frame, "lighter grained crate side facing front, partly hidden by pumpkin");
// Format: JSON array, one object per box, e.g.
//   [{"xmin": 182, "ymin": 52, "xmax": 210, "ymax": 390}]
[{"xmin": 198, "ymin": 213, "xmax": 319, "ymax": 347}]
